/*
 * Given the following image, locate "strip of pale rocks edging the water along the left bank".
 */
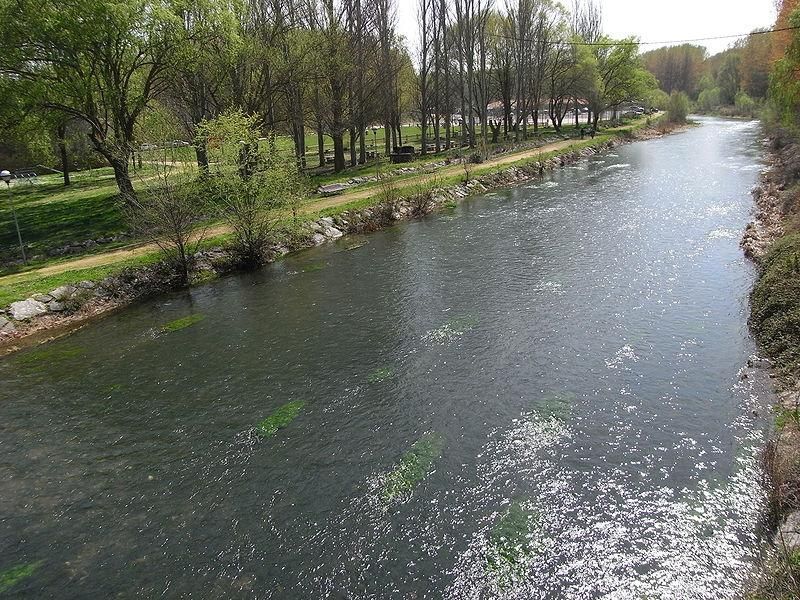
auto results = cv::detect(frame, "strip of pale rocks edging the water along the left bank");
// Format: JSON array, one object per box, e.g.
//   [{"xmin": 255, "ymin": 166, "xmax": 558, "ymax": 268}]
[{"xmin": 0, "ymin": 123, "xmax": 687, "ymax": 358}]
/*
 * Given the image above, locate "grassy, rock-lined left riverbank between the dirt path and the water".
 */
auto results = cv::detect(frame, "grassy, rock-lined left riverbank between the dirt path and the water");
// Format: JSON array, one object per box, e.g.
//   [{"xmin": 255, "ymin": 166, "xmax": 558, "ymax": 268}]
[{"xmin": 0, "ymin": 123, "xmax": 675, "ymax": 355}]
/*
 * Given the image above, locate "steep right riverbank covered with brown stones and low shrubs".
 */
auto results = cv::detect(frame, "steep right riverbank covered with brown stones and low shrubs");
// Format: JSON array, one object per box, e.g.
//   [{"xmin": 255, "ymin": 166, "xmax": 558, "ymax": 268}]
[{"xmin": 741, "ymin": 126, "xmax": 800, "ymax": 598}]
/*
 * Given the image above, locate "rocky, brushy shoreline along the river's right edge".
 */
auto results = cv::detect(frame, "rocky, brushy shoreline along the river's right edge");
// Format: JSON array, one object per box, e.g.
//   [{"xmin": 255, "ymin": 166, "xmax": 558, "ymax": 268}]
[{"xmin": 740, "ymin": 133, "xmax": 800, "ymax": 598}]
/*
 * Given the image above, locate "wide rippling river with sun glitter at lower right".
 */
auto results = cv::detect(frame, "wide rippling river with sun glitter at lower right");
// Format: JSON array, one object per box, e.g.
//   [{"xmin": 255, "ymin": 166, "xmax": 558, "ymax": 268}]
[{"xmin": 0, "ymin": 119, "xmax": 771, "ymax": 599}]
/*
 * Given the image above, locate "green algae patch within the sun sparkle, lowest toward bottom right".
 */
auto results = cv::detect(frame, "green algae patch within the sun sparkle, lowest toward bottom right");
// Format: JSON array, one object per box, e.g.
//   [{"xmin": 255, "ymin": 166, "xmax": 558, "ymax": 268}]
[{"xmin": 486, "ymin": 502, "xmax": 542, "ymax": 587}]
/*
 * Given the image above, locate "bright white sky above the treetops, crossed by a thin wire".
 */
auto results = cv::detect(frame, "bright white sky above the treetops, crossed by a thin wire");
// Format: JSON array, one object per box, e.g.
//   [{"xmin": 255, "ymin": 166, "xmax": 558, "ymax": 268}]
[{"xmin": 397, "ymin": 0, "xmax": 775, "ymax": 54}]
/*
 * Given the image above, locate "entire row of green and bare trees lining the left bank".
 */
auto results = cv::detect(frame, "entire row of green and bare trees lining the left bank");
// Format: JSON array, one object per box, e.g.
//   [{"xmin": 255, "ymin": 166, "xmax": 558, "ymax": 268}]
[{"xmin": 0, "ymin": 0, "xmax": 653, "ymax": 201}]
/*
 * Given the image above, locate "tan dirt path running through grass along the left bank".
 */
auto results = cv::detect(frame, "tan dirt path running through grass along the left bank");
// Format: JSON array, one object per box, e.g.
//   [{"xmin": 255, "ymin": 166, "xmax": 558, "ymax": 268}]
[{"xmin": 0, "ymin": 139, "xmax": 576, "ymax": 286}]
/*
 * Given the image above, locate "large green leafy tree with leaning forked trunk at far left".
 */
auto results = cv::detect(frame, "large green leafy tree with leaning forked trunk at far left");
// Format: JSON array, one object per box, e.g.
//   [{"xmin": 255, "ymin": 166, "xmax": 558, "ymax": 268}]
[{"xmin": 0, "ymin": 0, "xmax": 193, "ymax": 201}]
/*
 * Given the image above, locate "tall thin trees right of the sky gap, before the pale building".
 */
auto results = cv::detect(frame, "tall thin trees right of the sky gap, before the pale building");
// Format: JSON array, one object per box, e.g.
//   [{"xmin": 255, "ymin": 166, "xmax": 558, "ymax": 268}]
[{"xmin": 416, "ymin": 0, "xmax": 654, "ymax": 151}]
